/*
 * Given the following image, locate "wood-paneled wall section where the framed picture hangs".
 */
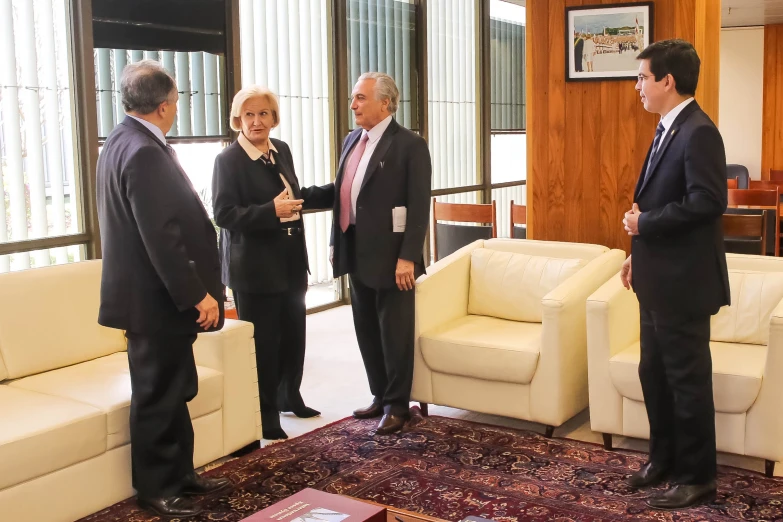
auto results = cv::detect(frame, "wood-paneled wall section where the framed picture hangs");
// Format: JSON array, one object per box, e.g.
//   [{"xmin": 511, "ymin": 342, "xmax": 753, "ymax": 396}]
[{"xmin": 527, "ymin": 0, "xmax": 720, "ymax": 251}]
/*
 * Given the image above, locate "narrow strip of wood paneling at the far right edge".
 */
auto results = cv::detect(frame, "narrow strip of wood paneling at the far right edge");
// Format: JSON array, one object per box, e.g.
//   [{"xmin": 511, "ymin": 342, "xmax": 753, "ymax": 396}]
[{"xmin": 761, "ymin": 24, "xmax": 783, "ymax": 179}]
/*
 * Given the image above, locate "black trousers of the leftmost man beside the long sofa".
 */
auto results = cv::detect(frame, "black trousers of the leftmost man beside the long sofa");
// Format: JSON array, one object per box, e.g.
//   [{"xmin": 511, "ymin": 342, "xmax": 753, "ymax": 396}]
[{"xmin": 125, "ymin": 332, "xmax": 198, "ymax": 498}]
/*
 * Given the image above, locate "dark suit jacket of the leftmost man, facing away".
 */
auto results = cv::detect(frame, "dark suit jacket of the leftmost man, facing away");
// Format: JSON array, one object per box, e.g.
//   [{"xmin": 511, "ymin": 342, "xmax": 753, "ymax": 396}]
[{"xmin": 97, "ymin": 116, "xmax": 225, "ymax": 334}]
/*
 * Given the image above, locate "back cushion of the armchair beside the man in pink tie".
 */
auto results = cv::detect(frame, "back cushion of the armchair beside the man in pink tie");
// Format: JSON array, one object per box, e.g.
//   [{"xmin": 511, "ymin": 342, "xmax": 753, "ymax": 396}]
[{"xmin": 468, "ymin": 248, "xmax": 586, "ymax": 323}]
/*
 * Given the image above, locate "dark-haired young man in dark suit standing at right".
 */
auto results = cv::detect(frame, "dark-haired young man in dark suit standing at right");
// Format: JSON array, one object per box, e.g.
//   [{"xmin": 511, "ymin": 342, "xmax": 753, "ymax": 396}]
[{"xmin": 620, "ymin": 40, "xmax": 730, "ymax": 509}]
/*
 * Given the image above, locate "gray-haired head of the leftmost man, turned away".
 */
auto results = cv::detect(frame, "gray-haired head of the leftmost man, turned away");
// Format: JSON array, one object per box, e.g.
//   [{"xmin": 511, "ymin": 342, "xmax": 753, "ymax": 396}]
[{"xmin": 120, "ymin": 60, "xmax": 177, "ymax": 114}]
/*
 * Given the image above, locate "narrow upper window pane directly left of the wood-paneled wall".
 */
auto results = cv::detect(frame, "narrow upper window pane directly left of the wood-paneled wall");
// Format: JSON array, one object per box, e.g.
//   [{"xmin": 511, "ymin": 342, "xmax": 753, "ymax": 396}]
[{"xmin": 489, "ymin": 0, "xmax": 525, "ymax": 130}]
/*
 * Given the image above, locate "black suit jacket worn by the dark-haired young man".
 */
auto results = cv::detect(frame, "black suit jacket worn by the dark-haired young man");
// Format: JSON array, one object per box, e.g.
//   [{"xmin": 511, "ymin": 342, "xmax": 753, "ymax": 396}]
[{"xmin": 631, "ymin": 101, "xmax": 730, "ymax": 316}]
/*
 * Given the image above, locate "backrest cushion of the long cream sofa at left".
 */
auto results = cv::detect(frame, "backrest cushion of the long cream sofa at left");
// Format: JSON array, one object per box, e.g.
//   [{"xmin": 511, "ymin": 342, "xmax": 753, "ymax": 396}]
[{"xmin": 0, "ymin": 261, "xmax": 125, "ymax": 379}]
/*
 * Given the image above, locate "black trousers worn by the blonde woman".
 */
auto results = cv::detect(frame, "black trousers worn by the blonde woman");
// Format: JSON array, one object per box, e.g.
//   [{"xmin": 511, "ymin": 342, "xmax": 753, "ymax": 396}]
[{"xmin": 234, "ymin": 235, "xmax": 307, "ymax": 427}]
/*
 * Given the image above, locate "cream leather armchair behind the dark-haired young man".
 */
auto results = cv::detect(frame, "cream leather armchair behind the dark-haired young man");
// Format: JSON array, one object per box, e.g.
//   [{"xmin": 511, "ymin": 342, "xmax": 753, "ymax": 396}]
[{"xmin": 587, "ymin": 254, "xmax": 783, "ymax": 476}]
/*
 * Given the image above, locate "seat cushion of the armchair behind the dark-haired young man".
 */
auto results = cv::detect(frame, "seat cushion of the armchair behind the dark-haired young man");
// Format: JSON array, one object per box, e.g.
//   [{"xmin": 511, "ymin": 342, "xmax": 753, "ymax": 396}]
[{"xmin": 609, "ymin": 342, "xmax": 767, "ymax": 413}]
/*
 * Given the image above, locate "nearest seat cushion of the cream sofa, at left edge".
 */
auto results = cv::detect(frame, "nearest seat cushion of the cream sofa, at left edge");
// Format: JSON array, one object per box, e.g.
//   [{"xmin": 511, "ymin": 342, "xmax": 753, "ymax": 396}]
[{"xmin": 0, "ymin": 385, "xmax": 106, "ymax": 488}]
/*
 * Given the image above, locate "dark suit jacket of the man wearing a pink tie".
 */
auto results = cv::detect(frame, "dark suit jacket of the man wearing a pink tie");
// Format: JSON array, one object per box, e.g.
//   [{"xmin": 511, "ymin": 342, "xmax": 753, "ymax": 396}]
[{"xmin": 331, "ymin": 120, "xmax": 432, "ymax": 289}]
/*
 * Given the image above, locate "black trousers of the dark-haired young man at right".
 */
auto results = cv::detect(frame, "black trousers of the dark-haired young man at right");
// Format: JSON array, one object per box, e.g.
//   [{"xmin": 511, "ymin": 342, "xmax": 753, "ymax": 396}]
[{"xmin": 639, "ymin": 309, "xmax": 717, "ymax": 484}]
